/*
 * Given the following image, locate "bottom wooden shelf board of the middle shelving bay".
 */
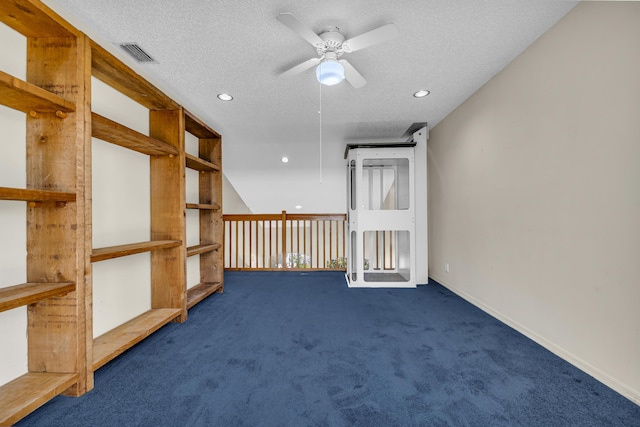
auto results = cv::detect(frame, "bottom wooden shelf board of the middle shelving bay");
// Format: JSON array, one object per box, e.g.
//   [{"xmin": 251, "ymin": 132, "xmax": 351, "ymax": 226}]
[{"xmin": 92, "ymin": 308, "xmax": 182, "ymax": 371}]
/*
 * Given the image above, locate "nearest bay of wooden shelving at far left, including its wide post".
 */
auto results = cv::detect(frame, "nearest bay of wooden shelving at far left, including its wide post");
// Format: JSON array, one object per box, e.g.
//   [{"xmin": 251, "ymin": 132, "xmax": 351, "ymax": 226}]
[{"xmin": 0, "ymin": 0, "xmax": 93, "ymax": 425}]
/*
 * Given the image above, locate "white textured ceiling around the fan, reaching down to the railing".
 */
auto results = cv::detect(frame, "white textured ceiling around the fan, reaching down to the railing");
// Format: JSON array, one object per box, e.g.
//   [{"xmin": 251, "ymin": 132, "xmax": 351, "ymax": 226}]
[{"xmin": 45, "ymin": 0, "xmax": 576, "ymax": 213}]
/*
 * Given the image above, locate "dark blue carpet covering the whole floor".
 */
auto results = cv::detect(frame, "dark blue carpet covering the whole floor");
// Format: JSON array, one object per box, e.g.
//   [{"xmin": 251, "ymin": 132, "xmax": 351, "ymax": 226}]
[{"xmin": 19, "ymin": 272, "xmax": 640, "ymax": 427}]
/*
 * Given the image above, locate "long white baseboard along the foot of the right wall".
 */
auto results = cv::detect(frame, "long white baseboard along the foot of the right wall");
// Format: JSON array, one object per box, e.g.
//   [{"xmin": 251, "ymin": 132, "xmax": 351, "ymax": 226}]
[{"xmin": 429, "ymin": 274, "xmax": 640, "ymax": 405}]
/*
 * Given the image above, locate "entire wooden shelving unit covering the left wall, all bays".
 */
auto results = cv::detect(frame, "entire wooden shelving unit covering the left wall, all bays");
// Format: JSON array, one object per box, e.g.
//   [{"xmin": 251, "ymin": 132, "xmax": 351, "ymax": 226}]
[{"xmin": 0, "ymin": 0, "xmax": 224, "ymax": 425}]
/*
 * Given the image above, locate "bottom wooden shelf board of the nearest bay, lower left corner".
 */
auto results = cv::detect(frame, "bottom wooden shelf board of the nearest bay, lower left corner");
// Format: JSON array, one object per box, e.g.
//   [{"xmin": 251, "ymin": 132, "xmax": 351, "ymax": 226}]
[{"xmin": 0, "ymin": 372, "xmax": 78, "ymax": 426}]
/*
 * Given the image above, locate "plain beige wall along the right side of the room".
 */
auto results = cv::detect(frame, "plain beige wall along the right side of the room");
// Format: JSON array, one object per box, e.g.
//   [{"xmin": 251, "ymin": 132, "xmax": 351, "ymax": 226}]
[{"xmin": 428, "ymin": 2, "xmax": 640, "ymax": 403}]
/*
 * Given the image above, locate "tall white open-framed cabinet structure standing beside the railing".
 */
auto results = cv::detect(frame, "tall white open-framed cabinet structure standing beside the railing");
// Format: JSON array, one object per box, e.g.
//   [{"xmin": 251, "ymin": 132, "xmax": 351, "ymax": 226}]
[{"xmin": 346, "ymin": 128, "xmax": 428, "ymax": 288}]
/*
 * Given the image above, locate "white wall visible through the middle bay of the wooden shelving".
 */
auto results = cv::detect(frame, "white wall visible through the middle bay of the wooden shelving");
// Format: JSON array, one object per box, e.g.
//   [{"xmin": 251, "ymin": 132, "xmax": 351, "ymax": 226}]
[{"xmin": 91, "ymin": 78, "xmax": 151, "ymax": 337}]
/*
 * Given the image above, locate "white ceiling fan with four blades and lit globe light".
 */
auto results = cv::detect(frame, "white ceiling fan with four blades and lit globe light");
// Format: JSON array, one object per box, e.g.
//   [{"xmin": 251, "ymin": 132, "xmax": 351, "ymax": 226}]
[{"xmin": 278, "ymin": 13, "xmax": 398, "ymax": 89}]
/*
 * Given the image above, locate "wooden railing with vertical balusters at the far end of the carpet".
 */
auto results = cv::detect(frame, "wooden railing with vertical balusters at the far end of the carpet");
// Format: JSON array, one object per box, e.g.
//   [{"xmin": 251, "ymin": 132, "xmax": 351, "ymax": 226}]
[{"xmin": 223, "ymin": 211, "xmax": 347, "ymax": 270}]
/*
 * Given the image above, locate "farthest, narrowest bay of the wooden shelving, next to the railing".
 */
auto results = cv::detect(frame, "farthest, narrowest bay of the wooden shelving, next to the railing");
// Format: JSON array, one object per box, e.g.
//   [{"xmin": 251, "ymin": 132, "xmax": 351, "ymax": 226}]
[{"xmin": 185, "ymin": 111, "xmax": 224, "ymax": 308}]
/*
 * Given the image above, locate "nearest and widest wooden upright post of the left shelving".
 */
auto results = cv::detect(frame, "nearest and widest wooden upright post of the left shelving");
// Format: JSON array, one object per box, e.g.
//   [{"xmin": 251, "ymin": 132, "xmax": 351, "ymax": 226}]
[{"xmin": 27, "ymin": 36, "xmax": 93, "ymax": 396}]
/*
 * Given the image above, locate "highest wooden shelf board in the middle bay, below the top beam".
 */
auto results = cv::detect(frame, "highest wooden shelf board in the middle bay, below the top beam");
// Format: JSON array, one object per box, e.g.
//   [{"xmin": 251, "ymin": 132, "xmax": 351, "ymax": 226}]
[{"xmin": 91, "ymin": 113, "xmax": 179, "ymax": 156}]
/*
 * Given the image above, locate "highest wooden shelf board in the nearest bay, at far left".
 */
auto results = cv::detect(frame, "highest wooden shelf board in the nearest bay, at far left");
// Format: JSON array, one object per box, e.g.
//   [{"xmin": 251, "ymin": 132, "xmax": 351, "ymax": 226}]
[{"xmin": 0, "ymin": 71, "xmax": 76, "ymax": 113}]
